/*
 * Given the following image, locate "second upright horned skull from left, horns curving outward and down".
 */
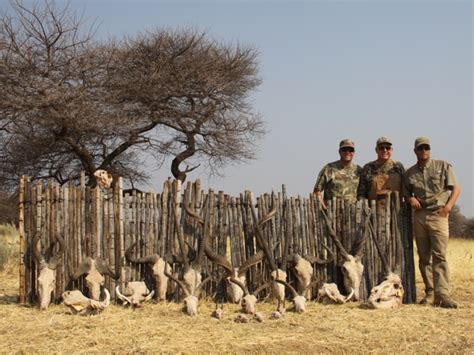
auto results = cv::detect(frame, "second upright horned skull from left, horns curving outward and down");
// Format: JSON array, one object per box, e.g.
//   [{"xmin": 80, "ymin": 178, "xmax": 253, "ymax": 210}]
[{"xmin": 71, "ymin": 257, "xmax": 120, "ymax": 301}]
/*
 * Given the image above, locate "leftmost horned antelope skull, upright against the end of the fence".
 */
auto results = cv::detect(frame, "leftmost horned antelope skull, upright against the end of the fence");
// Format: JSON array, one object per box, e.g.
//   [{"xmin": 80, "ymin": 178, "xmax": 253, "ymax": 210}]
[{"xmin": 32, "ymin": 232, "xmax": 64, "ymax": 310}]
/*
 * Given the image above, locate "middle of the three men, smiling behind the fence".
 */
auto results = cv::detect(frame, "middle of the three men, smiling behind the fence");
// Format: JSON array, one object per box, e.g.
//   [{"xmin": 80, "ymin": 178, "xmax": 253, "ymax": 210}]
[{"xmin": 358, "ymin": 137, "xmax": 405, "ymax": 205}]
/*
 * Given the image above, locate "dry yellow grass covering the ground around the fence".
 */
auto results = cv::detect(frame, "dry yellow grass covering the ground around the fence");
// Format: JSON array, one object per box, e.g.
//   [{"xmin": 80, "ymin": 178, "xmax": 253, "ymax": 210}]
[{"xmin": 0, "ymin": 235, "xmax": 474, "ymax": 353}]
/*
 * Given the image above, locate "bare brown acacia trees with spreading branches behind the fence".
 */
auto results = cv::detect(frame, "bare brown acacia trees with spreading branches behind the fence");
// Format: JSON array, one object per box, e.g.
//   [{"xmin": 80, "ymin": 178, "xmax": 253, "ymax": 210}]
[{"xmin": 0, "ymin": 0, "xmax": 264, "ymax": 192}]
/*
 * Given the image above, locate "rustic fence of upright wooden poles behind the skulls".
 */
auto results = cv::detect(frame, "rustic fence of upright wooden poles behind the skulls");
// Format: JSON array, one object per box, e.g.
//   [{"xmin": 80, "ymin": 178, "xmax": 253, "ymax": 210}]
[{"xmin": 19, "ymin": 178, "xmax": 416, "ymax": 303}]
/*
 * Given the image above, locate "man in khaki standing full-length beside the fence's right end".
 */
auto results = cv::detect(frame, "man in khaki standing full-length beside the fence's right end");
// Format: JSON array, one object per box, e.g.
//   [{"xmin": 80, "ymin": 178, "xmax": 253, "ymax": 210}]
[{"xmin": 404, "ymin": 137, "xmax": 461, "ymax": 308}]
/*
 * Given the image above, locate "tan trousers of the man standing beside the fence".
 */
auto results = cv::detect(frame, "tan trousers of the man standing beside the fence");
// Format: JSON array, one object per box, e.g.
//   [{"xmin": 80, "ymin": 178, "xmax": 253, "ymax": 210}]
[{"xmin": 414, "ymin": 209, "xmax": 449, "ymax": 296}]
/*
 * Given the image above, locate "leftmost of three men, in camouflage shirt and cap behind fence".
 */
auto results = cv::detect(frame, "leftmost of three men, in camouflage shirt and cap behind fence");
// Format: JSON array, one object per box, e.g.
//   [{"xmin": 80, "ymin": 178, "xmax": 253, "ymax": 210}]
[{"xmin": 313, "ymin": 139, "xmax": 361, "ymax": 208}]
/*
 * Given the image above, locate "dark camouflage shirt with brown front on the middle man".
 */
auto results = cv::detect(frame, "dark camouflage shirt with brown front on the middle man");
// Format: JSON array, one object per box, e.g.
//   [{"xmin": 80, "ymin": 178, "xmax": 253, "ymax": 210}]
[{"xmin": 357, "ymin": 159, "xmax": 405, "ymax": 200}]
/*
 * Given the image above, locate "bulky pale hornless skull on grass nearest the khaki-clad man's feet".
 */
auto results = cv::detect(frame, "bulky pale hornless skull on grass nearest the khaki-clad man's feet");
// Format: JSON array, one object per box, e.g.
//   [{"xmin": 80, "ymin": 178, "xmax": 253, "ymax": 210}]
[{"xmin": 368, "ymin": 272, "xmax": 404, "ymax": 309}]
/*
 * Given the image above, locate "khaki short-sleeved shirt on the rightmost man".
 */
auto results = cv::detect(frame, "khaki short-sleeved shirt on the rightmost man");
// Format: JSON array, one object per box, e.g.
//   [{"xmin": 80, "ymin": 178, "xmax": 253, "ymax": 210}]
[{"xmin": 404, "ymin": 159, "xmax": 457, "ymax": 210}]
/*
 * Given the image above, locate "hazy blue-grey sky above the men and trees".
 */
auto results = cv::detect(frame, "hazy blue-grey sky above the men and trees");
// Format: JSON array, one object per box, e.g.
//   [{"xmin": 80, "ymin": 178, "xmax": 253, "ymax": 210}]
[{"xmin": 4, "ymin": 0, "xmax": 474, "ymax": 217}]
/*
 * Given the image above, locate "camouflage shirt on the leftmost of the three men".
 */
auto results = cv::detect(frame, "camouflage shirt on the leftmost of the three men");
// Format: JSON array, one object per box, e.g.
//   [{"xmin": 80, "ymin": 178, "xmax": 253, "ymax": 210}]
[{"xmin": 313, "ymin": 160, "xmax": 362, "ymax": 202}]
